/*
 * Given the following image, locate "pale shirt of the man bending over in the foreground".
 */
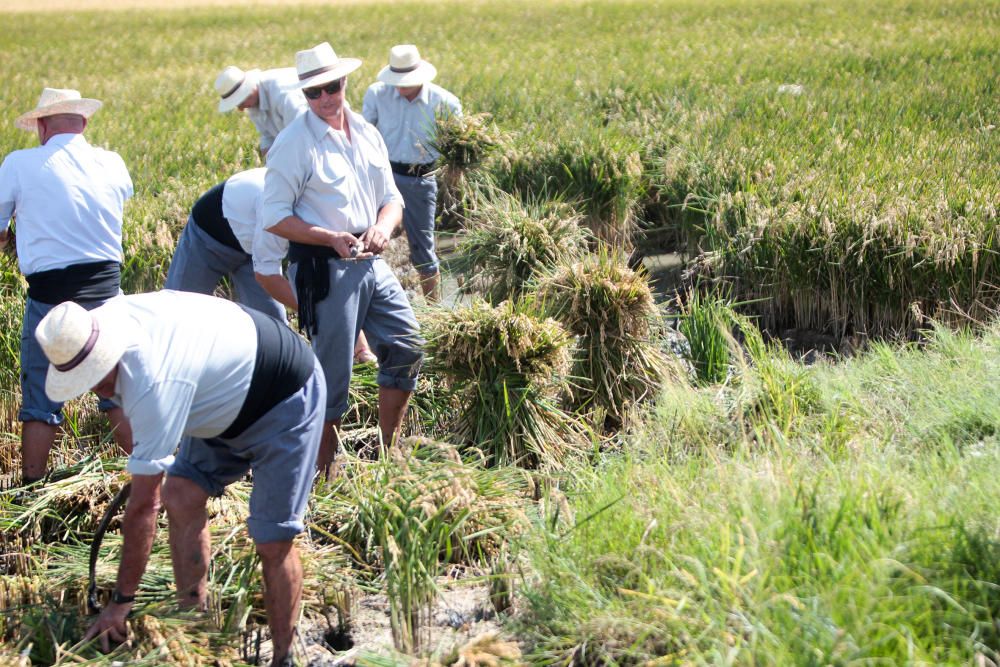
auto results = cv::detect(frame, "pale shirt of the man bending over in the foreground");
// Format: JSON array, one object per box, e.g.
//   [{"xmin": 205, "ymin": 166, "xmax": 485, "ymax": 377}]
[{"xmin": 105, "ymin": 290, "xmax": 257, "ymax": 475}]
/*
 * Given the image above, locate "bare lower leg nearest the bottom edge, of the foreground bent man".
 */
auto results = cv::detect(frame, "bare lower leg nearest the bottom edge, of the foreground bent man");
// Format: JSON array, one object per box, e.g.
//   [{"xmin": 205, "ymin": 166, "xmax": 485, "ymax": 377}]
[{"xmin": 257, "ymin": 540, "xmax": 302, "ymax": 665}]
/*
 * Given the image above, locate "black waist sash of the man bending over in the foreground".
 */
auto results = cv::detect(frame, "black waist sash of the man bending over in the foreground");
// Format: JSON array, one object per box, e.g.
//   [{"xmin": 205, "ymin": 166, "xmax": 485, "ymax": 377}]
[{"xmin": 219, "ymin": 307, "xmax": 315, "ymax": 438}]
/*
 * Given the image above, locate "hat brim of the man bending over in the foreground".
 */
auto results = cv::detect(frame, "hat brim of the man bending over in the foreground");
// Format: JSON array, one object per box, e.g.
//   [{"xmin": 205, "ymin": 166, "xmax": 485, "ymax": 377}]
[{"xmin": 45, "ymin": 302, "xmax": 135, "ymax": 403}]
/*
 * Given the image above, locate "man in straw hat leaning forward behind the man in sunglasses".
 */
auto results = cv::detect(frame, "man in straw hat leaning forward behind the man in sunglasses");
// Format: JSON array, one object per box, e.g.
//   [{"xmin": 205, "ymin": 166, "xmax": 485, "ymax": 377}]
[{"xmin": 215, "ymin": 65, "xmax": 308, "ymax": 155}]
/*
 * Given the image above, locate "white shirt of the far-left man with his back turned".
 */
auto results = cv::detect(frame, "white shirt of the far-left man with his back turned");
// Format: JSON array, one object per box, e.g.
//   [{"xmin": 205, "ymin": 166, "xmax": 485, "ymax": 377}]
[{"xmin": 0, "ymin": 134, "xmax": 133, "ymax": 275}]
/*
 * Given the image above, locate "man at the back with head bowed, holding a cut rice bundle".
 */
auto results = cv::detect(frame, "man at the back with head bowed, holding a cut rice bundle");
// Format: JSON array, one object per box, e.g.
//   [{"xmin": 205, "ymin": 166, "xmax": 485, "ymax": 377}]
[{"xmin": 362, "ymin": 44, "xmax": 462, "ymax": 297}]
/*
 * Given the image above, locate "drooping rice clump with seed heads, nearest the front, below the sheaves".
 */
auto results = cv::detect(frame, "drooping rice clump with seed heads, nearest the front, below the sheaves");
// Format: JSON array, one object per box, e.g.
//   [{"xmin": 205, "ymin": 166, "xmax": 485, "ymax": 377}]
[{"xmin": 316, "ymin": 438, "xmax": 526, "ymax": 654}]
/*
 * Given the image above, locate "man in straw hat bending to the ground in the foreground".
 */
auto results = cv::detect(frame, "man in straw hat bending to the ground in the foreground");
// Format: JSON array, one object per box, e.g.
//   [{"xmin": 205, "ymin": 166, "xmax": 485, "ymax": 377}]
[{"xmin": 34, "ymin": 290, "xmax": 326, "ymax": 665}]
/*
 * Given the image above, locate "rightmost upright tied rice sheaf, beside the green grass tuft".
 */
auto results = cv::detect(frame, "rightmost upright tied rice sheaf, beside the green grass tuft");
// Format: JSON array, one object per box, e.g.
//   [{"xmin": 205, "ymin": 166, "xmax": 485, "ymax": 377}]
[{"xmin": 537, "ymin": 249, "xmax": 668, "ymax": 426}]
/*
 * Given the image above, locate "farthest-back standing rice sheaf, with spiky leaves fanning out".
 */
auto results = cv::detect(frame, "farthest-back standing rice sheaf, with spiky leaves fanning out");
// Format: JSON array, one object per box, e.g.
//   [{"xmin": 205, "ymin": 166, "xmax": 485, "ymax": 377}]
[{"xmin": 450, "ymin": 187, "xmax": 587, "ymax": 304}]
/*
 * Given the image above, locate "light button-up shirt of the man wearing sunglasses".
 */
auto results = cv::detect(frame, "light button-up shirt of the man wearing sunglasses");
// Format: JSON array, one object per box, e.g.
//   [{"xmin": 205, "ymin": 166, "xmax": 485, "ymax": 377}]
[{"xmin": 261, "ymin": 108, "xmax": 403, "ymax": 234}]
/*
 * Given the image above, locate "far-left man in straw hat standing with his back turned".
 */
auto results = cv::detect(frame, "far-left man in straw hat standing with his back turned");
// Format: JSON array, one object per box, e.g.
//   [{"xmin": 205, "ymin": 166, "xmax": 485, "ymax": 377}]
[{"xmin": 0, "ymin": 88, "xmax": 132, "ymax": 483}]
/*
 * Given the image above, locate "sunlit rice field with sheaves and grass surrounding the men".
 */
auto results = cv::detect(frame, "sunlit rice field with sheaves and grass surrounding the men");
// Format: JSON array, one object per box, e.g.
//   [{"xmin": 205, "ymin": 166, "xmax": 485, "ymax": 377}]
[{"xmin": 0, "ymin": 0, "xmax": 1000, "ymax": 665}]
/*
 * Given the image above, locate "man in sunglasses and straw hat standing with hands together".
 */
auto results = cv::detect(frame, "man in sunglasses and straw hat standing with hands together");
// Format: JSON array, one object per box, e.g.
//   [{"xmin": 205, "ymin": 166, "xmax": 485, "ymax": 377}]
[{"xmin": 261, "ymin": 42, "xmax": 423, "ymax": 471}]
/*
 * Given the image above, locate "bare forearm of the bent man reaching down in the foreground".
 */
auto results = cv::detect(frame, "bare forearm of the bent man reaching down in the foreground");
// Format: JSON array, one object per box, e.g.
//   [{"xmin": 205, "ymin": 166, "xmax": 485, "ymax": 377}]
[{"xmin": 117, "ymin": 474, "xmax": 163, "ymax": 595}]
